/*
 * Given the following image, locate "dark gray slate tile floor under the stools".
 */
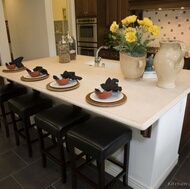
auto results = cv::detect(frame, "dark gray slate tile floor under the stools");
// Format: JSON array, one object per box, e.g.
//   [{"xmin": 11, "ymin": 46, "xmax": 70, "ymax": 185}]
[{"xmin": 0, "ymin": 114, "xmax": 190, "ymax": 189}]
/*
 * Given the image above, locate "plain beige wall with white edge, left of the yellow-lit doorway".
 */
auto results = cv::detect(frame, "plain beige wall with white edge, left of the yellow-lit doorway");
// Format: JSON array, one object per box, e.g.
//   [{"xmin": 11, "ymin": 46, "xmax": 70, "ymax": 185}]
[{"xmin": 3, "ymin": 0, "xmax": 56, "ymax": 60}]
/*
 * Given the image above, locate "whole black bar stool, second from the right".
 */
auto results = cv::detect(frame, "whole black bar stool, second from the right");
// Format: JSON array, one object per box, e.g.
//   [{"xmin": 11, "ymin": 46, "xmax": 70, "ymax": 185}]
[{"xmin": 35, "ymin": 104, "xmax": 89, "ymax": 183}]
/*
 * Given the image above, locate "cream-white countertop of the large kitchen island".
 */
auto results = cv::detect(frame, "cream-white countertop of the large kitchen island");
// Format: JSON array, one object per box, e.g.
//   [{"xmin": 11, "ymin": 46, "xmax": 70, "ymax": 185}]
[{"xmin": 0, "ymin": 55, "xmax": 190, "ymax": 130}]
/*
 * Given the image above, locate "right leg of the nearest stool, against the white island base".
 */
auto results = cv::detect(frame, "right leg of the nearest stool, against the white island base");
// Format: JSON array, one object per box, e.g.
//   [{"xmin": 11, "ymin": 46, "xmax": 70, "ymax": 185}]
[{"xmin": 123, "ymin": 143, "xmax": 130, "ymax": 186}]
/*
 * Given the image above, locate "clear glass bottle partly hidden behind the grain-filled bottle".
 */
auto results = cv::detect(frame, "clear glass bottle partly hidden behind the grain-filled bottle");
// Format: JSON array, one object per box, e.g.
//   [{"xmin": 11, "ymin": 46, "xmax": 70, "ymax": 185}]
[{"xmin": 65, "ymin": 31, "xmax": 76, "ymax": 60}]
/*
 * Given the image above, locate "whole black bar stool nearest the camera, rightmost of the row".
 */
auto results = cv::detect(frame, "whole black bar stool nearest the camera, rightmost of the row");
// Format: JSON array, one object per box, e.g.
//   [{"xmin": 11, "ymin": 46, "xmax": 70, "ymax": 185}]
[{"xmin": 67, "ymin": 117, "xmax": 132, "ymax": 189}]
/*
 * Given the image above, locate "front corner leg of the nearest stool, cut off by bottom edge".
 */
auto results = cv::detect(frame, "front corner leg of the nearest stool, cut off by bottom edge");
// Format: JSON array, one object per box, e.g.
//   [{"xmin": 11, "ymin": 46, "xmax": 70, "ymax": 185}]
[{"xmin": 96, "ymin": 161, "xmax": 105, "ymax": 189}]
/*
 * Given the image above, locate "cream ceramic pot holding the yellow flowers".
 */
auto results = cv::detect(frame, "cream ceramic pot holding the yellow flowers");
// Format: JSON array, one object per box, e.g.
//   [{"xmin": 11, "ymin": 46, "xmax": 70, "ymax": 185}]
[{"xmin": 120, "ymin": 52, "xmax": 146, "ymax": 81}]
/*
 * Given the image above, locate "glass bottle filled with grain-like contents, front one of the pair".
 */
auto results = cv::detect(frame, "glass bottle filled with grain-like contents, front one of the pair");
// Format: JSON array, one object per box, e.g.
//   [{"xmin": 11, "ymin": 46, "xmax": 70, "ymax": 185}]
[{"xmin": 58, "ymin": 36, "xmax": 70, "ymax": 63}]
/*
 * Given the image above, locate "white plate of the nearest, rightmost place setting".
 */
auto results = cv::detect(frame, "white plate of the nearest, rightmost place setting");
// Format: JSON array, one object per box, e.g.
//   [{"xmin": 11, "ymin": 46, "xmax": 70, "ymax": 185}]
[{"xmin": 90, "ymin": 92, "xmax": 123, "ymax": 102}]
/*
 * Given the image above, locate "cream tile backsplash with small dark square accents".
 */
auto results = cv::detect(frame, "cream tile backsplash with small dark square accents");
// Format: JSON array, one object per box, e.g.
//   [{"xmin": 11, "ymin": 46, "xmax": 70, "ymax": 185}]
[{"xmin": 143, "ymin": 10, "xmax": 190, "ymax": 51}]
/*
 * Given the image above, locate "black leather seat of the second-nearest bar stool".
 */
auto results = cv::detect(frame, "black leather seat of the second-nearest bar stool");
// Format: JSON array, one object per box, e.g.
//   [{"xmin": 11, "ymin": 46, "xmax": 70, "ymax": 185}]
[{"xmin": 35, "ymin": 104, "xmax": 89, "ymax": 137}]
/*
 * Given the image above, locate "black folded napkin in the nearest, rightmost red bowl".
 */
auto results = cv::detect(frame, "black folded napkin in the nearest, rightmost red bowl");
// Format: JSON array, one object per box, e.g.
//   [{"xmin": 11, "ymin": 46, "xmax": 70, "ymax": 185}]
[{"xmin": 95, "ymin": 77, "xmax": 122, "ymax": 92}]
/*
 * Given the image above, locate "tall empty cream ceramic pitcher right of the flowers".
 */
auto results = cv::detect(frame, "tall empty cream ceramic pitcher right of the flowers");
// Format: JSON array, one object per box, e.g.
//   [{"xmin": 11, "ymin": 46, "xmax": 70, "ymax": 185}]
[{"xmin": 153, "ymin": 40, "xmax": 185, "ymax": 88}]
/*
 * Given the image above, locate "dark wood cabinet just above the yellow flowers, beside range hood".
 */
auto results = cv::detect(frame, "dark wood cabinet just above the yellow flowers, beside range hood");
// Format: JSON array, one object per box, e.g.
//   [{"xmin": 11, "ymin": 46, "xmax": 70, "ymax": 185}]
[{"xmin": 106, "ymin": 0, "xmax": 129, "ymax": 27}]
